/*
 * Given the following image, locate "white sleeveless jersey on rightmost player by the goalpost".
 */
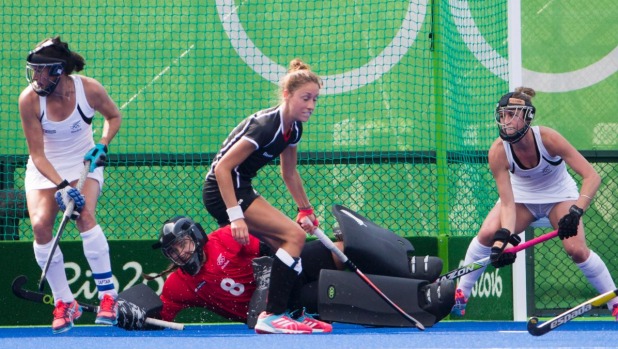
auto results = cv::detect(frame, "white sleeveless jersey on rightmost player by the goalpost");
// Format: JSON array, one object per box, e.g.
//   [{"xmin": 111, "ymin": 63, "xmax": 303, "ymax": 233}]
[{"xmin": 503, "ymin": 126, "xmax": 579, "ymax": 204}]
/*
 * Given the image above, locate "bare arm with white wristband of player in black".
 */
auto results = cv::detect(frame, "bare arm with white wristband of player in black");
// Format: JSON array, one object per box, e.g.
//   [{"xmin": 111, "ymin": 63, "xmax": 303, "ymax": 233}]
[{"xmin": 215, "ymin": 139, "xmax": 256, "ymax": 245}]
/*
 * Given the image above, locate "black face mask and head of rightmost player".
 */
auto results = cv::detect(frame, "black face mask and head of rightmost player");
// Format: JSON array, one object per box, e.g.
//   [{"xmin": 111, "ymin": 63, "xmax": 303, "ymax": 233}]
[{"xmin": 494, "ymin": 92, "xmax": 536, "ymax": 144}]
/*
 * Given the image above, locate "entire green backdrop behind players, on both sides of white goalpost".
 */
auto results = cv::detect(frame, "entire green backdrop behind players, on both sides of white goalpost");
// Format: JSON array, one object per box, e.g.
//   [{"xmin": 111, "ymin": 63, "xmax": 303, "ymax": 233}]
[{"xmin": 0, "ymin": 0, "xmax": 618, "ymax": 316}]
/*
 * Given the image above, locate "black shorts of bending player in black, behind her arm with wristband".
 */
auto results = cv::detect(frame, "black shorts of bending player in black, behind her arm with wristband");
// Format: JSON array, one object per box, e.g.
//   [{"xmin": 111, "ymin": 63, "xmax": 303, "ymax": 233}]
[{"xmin": 202, "ymin": 180, "xmax": 260, "ymax": 227}]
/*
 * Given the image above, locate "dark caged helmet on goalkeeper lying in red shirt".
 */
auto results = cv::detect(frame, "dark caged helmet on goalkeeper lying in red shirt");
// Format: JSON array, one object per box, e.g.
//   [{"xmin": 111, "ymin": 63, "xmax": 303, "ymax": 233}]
[{"xmin": 153, "ymin": 216, "xmax": 208, "ymax": 275}]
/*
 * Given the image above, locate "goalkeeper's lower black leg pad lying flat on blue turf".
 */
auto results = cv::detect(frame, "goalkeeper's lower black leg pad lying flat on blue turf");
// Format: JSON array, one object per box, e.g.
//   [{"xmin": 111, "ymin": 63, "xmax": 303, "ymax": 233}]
[{"xmin": 318, "ymin": 270, "xmax": 455, "ymax": 327}]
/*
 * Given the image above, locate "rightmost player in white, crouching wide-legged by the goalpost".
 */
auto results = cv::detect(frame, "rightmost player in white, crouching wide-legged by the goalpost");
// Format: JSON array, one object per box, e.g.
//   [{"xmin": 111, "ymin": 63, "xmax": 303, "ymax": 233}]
[{"xmin": 451, "ymin": 87, "xmax": 618, "ymax": 318}]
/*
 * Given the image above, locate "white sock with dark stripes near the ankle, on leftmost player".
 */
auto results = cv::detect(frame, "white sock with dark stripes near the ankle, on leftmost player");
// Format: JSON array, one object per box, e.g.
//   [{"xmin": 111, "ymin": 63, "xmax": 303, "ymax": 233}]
[{"xmin": 81, "ymin": 225, "xmax": 118, "ymax": 299}]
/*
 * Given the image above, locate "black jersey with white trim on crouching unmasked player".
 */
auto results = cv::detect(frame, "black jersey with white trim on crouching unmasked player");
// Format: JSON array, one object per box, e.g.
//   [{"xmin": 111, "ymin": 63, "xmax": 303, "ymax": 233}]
[{"xmin": 206, "ymin": 107, "xmax": 303, "ymax": 189}]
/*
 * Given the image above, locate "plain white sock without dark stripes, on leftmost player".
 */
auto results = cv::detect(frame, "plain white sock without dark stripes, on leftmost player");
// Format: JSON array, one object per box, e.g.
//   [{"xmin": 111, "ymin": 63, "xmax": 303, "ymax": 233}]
[{"xmin": 33, "ymin": 240, "xmax": 75, "ymax": 303}]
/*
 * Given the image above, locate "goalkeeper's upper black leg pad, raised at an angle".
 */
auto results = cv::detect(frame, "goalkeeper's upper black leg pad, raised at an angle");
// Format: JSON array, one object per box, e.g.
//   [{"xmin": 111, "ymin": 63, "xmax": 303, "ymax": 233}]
[{"xmin": 333, "ymin": 205, "xmax": 442, "ymax": 281}]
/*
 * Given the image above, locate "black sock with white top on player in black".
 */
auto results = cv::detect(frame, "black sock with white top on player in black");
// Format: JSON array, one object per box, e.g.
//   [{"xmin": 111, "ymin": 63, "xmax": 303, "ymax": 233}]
[{"xmin": 266, "ymin": 248, "xmax": 302, "ymax": 314}]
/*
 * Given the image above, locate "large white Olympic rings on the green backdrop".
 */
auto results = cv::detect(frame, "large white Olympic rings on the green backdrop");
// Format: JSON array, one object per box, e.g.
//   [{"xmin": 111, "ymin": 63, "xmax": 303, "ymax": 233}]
[{"xmin": 216, "ymin": 0, "xmax": 618, "ymax": 95}]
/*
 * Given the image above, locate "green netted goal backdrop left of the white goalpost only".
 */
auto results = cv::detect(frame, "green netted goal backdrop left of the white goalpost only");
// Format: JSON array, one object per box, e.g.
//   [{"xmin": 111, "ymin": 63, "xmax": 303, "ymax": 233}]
[{"xmin": 0, "ymin": 0, "xmax": 508, "ymax": 239}]
